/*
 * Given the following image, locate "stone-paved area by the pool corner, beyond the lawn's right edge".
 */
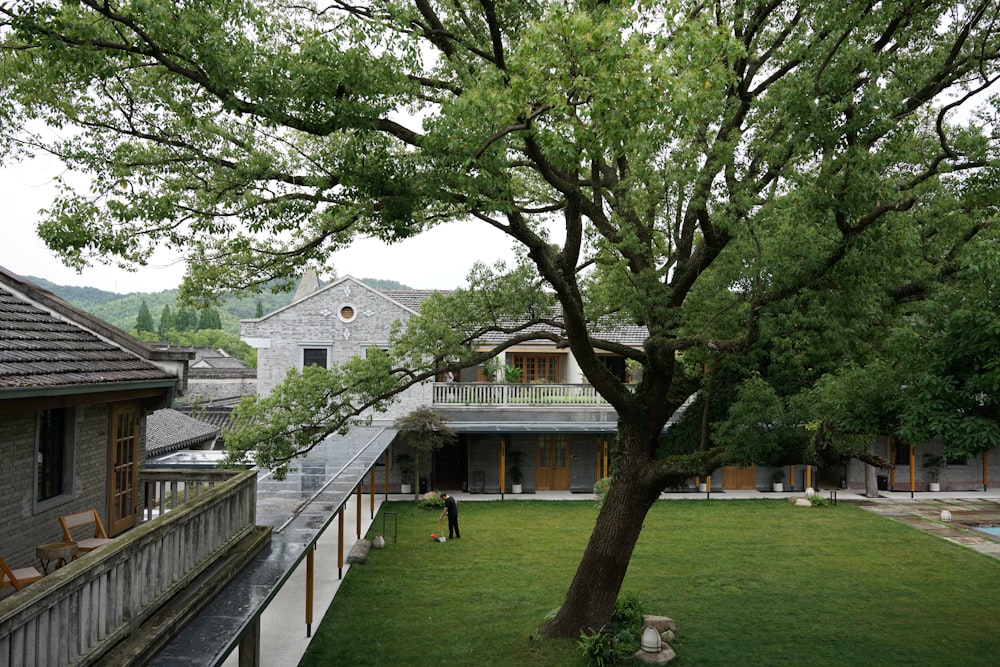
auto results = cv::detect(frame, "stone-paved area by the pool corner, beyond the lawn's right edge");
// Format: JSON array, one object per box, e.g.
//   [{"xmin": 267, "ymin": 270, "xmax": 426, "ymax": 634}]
[{"xmin": 855, "ymin": 498, "xmax": 1000, "ymax": 558}]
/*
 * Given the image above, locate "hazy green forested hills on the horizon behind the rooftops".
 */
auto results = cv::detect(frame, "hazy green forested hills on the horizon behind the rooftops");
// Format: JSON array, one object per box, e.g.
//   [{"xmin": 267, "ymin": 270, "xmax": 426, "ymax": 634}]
[{"xmin": 24, "ymin": 276, "xmax": 410, "ymax": 337}]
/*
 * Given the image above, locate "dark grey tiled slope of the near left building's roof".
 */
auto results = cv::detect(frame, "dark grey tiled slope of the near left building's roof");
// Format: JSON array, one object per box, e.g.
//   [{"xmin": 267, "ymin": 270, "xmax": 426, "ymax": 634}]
[{"xmin": 0, "ymin": 282, "xmax": 175, "ymax": 389}]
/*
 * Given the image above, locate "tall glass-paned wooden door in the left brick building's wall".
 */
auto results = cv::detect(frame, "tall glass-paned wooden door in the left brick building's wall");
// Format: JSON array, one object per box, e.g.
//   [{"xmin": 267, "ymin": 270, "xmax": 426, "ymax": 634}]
[{"xmin": 108, "ymin": 403, "xmax": 140, "ymax": 535}]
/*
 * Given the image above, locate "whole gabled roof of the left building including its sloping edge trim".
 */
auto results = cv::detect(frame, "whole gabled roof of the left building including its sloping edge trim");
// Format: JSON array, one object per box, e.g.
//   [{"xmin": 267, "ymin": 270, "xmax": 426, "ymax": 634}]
[{"xmin": 0, "ymin": 268, "xmax": 177, "ymax": 395}]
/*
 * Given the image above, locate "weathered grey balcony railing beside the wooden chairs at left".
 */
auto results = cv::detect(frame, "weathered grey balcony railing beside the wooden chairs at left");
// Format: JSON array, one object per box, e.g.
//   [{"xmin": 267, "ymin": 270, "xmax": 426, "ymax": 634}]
[{"xmin": 0, "ymin": 470, "xmax": 257, "ymax": 667}]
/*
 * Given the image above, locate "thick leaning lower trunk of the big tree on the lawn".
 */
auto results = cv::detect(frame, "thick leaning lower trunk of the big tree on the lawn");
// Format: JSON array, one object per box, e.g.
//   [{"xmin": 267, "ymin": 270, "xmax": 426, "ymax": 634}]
[{"xmin": 543, "ymin": 448, "xmax": 660, "ymax": 637}]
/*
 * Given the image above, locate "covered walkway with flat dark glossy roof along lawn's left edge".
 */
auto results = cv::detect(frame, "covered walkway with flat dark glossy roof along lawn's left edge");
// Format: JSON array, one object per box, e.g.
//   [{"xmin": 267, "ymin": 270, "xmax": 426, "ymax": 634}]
[{"xmin": 150, "ymin": 426, "xmax": 395, "ymax": 667}]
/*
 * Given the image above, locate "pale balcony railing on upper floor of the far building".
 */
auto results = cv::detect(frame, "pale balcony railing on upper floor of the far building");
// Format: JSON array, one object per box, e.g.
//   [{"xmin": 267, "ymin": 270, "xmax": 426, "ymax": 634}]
[{"xmin": 433, "ymin": 382, "xmax": 608, "ymax": 407}]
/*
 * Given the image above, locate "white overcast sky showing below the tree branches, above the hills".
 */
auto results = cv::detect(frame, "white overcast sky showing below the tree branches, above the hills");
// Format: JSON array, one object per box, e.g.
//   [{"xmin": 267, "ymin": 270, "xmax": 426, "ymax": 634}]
[{"xmin": 0, "ymin": 158, "xmax": 514, "ymax": 294}]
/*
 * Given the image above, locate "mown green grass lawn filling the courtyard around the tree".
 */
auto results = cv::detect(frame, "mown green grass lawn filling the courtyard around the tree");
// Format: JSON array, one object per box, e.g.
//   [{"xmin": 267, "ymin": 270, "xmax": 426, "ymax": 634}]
[{"xmin": 301, "ymin": 500, "xmax": 1000, "ymax": 667}]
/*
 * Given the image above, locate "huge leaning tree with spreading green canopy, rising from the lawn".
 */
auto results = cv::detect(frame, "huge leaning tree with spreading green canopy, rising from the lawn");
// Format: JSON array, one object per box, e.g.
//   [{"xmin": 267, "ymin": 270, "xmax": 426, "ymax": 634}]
[{"xmin": 0, "ymin": 0, "xmax": 1000, "ymax": 636}]
